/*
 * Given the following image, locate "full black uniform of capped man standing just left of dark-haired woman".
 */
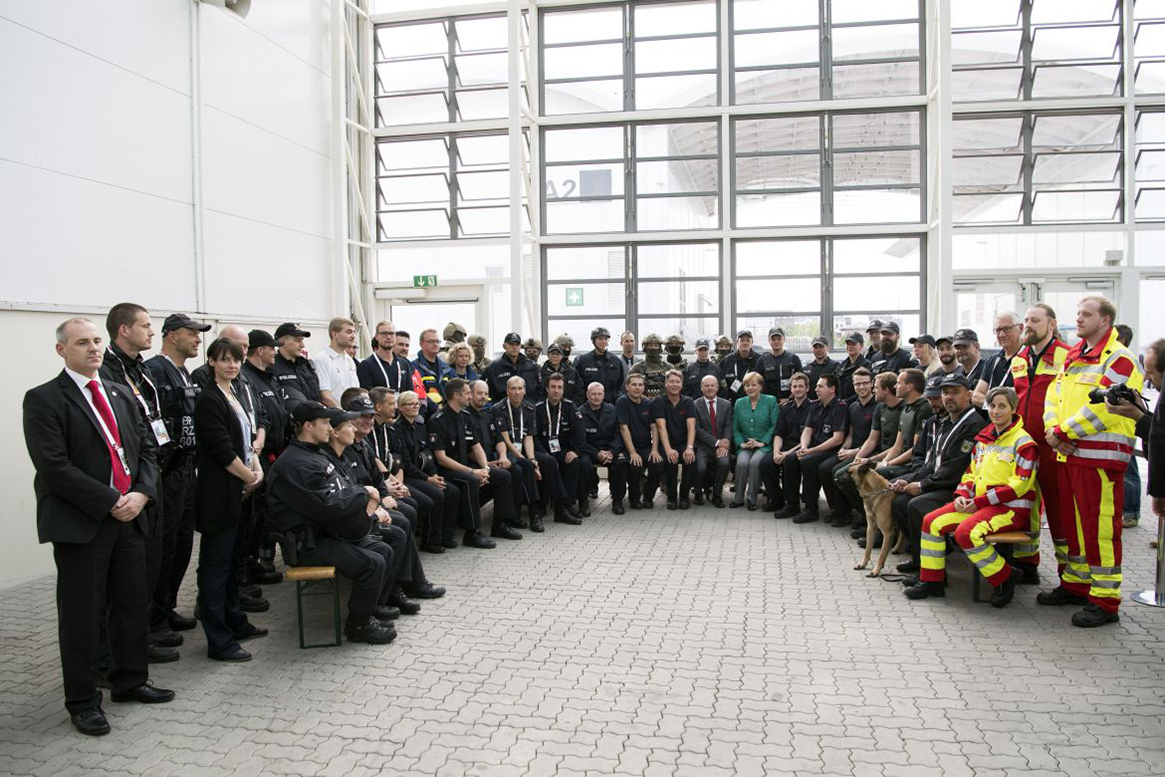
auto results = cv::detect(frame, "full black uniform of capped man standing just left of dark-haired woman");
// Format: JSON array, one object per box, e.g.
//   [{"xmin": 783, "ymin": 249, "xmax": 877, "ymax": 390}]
[{"xmin": 146, "ymin": 354, "xmax": 198, "ymax": 631}]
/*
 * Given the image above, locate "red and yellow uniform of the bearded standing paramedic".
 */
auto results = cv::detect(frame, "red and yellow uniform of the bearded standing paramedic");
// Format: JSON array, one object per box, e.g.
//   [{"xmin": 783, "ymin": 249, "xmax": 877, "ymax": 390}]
[{"xmin": 1011, "ymin": 337, "xmax": 1073, "ymax": 572}]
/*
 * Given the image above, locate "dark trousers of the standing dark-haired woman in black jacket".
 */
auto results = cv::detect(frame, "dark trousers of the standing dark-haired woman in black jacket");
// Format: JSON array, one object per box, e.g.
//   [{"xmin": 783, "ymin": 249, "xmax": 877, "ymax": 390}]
[{"xmin": 198, "ymin": 519, "xmax": 248, "ymax": 657}]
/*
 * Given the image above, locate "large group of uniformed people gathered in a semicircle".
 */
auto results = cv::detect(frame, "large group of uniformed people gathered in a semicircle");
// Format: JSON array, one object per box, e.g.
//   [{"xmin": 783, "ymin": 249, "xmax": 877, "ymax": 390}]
[{"xmin": 24, "ymin": 297, "xmax": 1165, "ymax": 735}]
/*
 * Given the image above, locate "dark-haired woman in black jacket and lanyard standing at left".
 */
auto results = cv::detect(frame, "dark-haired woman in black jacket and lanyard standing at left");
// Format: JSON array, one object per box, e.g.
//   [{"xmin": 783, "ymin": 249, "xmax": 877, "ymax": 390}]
[{"xmin": 195, "ymin": 338, "xmax": 267, "ymax": 661}]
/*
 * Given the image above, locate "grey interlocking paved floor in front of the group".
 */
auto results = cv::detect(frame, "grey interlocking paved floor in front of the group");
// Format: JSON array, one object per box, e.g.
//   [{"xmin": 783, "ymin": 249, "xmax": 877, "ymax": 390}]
[{"xmin": 0, "ymin": 500, "xmax": 1165, "ymax": 777}]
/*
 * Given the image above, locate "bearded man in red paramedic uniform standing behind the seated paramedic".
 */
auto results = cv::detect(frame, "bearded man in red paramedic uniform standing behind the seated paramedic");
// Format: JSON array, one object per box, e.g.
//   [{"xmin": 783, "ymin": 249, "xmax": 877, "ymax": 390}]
[{"xmin": 1011, "ymin": 303, "xmax": 1074, "ymax": 584}]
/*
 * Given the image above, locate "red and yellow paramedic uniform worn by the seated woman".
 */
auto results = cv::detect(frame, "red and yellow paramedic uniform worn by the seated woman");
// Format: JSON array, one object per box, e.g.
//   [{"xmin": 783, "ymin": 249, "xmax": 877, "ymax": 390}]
[{"xmin": 918, "ymin": 418, "xmax": 1039, "ymax": 587}]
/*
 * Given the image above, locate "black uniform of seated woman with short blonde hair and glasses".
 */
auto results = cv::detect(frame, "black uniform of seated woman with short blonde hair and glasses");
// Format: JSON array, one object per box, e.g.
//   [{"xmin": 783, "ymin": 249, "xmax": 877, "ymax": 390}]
[{"xmin": 396, "ymin": 415, "xmax": 461, "ymax": 552}]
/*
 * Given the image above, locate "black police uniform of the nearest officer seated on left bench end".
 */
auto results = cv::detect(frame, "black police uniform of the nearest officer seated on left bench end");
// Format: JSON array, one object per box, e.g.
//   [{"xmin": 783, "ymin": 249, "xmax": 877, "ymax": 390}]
[{"xmin": 267, "ymin": 440, "xmax": 393, "ymax": 627}]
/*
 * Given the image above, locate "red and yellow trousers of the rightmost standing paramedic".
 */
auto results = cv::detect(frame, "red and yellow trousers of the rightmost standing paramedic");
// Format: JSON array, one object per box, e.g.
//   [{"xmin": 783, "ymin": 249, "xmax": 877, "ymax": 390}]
[{"xmin": 1060, "ymin": 464, "xmax": 1124, "ymax": 613}]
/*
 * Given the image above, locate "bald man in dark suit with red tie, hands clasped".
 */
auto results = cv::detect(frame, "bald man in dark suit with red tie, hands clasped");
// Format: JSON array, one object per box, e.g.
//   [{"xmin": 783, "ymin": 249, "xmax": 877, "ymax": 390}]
[{"xmin": 23, "ymin": 318, "xmax": 174, "ymax": 736}]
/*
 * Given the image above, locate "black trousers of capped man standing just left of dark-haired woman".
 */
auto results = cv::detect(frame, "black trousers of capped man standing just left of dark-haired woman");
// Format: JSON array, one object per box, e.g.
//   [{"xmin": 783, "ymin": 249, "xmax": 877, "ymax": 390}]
[{"xmin": 149, "ymin": 453, "xmax": 196, "ymax": 631}]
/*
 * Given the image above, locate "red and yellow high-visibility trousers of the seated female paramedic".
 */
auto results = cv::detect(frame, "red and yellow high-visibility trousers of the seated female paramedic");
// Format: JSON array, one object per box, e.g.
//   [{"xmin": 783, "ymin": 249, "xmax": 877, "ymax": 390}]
[{"xmin": 918, "ymin": 502, "xmax": 1031, "ymax": 587}]
